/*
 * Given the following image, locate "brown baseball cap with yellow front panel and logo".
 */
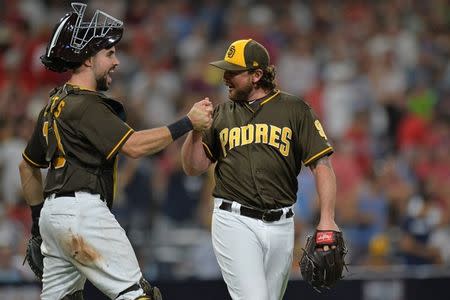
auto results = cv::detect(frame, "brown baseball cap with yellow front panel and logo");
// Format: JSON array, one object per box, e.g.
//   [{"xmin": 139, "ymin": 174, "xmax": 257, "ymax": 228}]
[{"xmin": 209, "ymin": 39, "xmax": 270, "ymax": 71}]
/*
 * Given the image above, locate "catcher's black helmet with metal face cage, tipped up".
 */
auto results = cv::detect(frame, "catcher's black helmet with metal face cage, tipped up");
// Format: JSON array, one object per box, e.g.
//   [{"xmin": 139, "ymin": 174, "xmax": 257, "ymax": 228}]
[{"xmin": 41, "ymin": 3, "xmax": 123, "ymax": 73}]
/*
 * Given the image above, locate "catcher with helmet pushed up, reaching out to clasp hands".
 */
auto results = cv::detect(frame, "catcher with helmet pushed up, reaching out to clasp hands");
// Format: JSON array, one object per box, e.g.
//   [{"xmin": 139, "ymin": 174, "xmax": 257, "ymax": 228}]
[{"xmin": 19, "ymin": 3, "xmax": 212, "ymax": 300}]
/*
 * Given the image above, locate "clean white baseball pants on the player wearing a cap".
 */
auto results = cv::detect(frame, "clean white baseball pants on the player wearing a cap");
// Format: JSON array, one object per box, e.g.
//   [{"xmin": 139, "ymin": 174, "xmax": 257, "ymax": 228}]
[{"xmin": 212, "ymin": 198, "xmax": 294, "ymax": 300}]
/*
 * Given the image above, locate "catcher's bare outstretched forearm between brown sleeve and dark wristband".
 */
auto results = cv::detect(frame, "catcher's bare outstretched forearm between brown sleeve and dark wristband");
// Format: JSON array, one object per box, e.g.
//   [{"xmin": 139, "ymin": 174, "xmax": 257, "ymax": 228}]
[{"xmin": 121, "ymin": 127, "xmax": 173, "ymax": 158}]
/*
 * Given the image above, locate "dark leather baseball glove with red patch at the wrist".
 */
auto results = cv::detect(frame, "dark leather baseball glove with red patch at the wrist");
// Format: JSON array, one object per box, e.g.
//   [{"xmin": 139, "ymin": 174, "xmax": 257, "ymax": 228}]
[{"xmin": 299, "ymin": 230, "xmax": 347, "ymax": 292}]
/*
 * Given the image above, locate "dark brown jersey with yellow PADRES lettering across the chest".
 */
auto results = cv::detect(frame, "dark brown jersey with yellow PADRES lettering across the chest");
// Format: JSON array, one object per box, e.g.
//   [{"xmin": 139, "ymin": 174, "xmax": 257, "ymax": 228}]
[{"xmin": 203, "ymin": 90, "xmax": 333, "ymax": 209}]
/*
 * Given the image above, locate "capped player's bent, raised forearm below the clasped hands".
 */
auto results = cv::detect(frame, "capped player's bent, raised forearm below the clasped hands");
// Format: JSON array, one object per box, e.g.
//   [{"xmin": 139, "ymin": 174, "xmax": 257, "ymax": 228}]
[{"xmin": 181, "ymin": 131, "xmax": 211, "ymax": 176}]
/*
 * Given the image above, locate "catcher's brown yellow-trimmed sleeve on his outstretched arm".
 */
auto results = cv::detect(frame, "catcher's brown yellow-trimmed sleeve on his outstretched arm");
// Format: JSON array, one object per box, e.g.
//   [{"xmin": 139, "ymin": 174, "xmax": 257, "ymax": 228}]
[{"xmin": 79, "ymin": 102, "xmax": 134, "ymax": 159}]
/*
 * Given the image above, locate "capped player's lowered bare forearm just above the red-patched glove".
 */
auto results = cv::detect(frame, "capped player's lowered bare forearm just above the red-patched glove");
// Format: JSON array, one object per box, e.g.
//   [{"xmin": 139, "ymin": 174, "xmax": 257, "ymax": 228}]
[{"xmin": 311, "ymin": 157, "xmax": 338, "ymax": 230}]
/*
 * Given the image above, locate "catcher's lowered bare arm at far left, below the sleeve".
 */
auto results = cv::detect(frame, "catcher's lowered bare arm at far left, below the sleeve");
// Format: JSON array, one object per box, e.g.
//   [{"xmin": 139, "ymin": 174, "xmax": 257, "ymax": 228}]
[{"xmin": 19, "ymin": 160, "xmax": 44, "ymax": 206}]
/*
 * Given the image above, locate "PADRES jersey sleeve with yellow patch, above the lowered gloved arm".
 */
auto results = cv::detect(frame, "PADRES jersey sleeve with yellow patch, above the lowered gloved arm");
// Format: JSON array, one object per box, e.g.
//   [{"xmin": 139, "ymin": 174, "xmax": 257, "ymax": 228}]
[{"xmin": 299, "ymin": 105, "xmax": 333, "ymax": 166}]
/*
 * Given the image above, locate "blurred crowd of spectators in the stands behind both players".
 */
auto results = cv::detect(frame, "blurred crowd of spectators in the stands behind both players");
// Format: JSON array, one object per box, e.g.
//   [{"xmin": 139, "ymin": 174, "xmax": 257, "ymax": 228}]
[{"xmin": 0, "ymin": 0, "xmax": 450, "ymax": 281}]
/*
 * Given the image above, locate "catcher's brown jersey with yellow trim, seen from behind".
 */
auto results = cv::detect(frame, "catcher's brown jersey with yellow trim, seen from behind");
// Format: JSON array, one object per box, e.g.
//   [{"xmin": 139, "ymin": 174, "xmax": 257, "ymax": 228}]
[{"xmin": 23, "ymin": 85, "xmax": 133, "ymax": 206}]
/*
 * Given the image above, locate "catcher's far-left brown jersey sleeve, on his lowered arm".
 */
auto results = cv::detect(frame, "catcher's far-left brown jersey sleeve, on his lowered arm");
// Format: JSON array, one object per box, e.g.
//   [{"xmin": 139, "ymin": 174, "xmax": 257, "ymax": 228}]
[{"xmin": 22, "ymin": 109, "xmax": 49, "ymax": 168}]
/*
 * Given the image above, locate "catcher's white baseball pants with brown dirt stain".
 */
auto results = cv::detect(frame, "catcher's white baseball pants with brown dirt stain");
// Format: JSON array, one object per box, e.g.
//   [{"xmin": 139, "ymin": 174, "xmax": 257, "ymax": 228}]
[{"xmin": 39, "ymin": 192, "xmax": 143, "ymax": 300}]
